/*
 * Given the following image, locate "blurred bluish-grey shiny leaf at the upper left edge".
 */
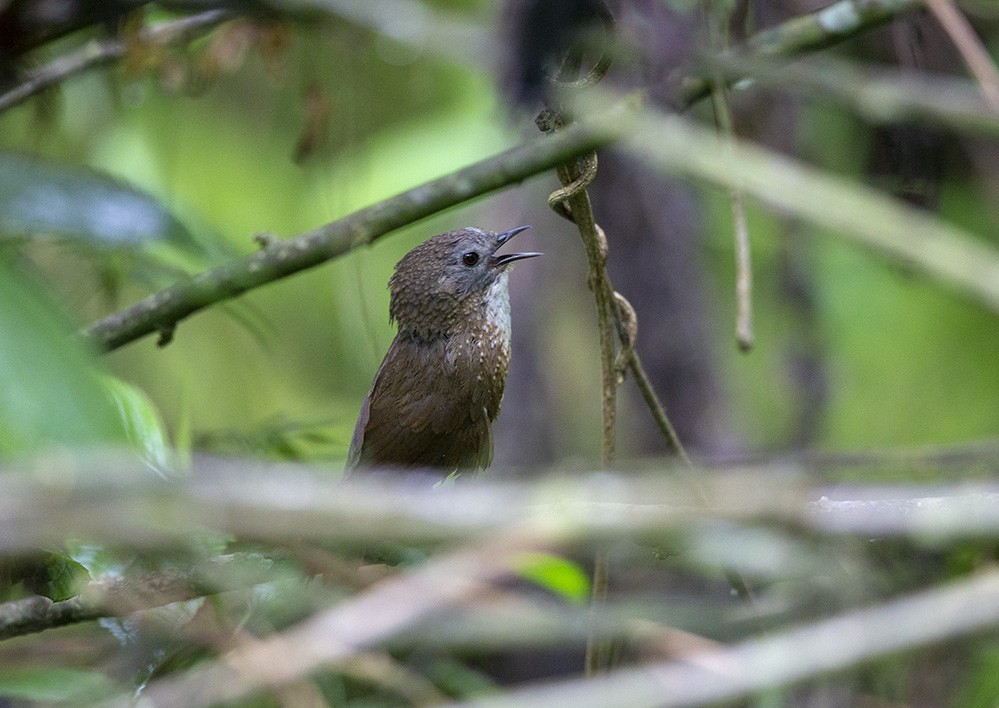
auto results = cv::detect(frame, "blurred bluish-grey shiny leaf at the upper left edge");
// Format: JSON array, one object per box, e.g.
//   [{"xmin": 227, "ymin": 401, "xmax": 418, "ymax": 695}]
[{"xmin": 0, "ymin": 151, "xmax": 193, "ymax": 245}]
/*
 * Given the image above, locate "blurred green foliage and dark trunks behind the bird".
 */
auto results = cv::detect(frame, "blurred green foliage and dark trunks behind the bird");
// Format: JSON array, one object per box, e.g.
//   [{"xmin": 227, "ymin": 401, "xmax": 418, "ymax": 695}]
[{"xmin": 0, "ymin": 0, "xmax": 999, "ymax": 467}]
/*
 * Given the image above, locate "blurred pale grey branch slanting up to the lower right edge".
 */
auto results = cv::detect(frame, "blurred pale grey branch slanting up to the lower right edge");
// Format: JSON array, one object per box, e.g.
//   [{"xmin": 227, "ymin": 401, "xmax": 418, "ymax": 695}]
[{"xmin": 466, "ymin": 570, "xmax": 999, "ymax": 708}]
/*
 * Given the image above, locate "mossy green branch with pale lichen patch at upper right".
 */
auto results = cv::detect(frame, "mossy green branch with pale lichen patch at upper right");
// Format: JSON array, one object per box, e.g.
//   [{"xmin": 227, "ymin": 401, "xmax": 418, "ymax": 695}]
[{"xmin": 680, "ymin": 0, "xmax": 923, "ymax": 107}]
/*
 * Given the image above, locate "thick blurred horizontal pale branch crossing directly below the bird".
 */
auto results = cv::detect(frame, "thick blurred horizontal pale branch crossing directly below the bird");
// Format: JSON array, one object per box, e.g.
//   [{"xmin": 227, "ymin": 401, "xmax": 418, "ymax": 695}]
[{"xmin": 0, "ymin": 449, "xmax": 999, "ymax": 554}]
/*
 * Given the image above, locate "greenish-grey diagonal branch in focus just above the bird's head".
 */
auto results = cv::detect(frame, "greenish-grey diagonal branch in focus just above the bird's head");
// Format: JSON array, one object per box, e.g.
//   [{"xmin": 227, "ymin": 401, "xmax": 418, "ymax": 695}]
[{"xmin": 83, "ymin": 115, "xmax": 620, "ymax": 351}]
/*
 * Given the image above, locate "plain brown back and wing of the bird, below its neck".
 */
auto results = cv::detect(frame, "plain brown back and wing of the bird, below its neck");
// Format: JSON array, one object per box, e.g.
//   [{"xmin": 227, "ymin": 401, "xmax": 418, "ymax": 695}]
[{"xmin": 347, "ymin": 337, "xmax": 492, "ymax": 472}]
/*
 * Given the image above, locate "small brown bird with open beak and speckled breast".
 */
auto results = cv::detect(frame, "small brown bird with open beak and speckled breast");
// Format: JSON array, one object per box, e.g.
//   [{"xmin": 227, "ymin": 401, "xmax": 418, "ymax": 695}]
[{"xmin": 346, "ymin": 226, "xmax": 541, "ymax": 475}]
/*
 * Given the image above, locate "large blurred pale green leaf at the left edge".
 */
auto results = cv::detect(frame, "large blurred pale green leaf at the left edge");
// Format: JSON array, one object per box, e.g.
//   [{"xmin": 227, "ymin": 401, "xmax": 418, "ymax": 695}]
[{"xmin": 0, "ymin": 263, "xmax": 127, "ymax": 456}]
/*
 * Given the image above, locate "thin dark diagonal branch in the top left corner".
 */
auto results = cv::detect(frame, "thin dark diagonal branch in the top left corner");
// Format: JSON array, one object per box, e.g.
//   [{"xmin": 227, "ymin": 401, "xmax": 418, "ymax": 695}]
[{"xmin": 0, "ymin": 10, "xmax": 233, "ymax": 112}]
